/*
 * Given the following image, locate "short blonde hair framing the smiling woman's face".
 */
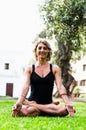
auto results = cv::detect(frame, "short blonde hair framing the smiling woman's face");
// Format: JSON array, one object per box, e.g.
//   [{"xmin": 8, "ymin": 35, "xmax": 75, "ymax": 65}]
[{"xmin": 33, "ymin": 39, "xmax": 52, "ymax": 61}]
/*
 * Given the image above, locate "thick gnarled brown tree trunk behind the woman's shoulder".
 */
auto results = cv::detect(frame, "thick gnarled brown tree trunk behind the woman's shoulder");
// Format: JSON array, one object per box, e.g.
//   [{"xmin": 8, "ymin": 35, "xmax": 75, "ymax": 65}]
[{"xmin": 58, "ymin": 41, "xmax": 75, "ymax": 95}]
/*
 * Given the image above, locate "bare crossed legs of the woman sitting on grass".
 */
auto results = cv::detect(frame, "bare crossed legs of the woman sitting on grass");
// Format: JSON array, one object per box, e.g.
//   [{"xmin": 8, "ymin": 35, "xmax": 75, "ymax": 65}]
[{"xmin": 12, "ymin": 100, "xmax": 68, "ymax": 117}]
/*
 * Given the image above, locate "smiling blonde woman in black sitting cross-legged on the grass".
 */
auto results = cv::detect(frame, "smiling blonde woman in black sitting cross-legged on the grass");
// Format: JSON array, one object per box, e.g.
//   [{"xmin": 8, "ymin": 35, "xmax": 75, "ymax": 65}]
[{"xmin": 12, "ymin": 39, "xmax": 75, "ymax": 117}]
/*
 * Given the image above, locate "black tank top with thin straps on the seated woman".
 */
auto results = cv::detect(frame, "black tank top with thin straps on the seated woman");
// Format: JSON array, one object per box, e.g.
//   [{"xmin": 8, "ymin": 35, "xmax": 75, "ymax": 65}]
[{"xmin": 28, "ymin": 64, "xmax": 55, "ymax": 104}]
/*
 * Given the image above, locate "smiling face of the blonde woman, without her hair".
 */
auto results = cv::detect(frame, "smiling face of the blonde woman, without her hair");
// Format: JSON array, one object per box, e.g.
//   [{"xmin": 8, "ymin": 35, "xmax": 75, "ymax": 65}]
[{"xmin": 36, "ymin": 43, "xmax": 48, "ymax": 59}]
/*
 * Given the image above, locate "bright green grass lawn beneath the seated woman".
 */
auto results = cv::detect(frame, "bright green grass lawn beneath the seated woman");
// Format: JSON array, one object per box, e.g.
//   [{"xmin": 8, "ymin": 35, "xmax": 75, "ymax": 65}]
[{"xmin": 0, "ymin": 100, "xmax": 86, "ymax": 130}]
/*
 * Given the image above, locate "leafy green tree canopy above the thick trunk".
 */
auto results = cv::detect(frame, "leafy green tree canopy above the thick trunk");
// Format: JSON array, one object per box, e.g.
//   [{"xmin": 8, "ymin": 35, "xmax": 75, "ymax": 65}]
[{"xmin": 40, "ymin": 0, "xmax": 86, "ymax": 58}]
